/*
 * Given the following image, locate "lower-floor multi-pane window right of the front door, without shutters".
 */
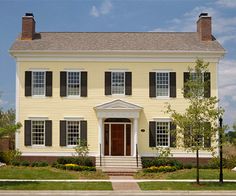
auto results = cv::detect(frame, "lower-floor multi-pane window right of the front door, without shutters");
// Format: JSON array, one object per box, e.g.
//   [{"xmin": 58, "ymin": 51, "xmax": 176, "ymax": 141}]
[{"xmin": 156, "ymin": 122, "xmax": 170, "ymax": 146}]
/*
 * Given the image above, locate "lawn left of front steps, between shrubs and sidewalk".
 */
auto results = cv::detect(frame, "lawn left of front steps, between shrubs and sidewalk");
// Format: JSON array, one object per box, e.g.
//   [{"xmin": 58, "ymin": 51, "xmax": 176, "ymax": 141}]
[{"xmin": 0, "ymin": 166, "xmax": 108, "ymax": 179}]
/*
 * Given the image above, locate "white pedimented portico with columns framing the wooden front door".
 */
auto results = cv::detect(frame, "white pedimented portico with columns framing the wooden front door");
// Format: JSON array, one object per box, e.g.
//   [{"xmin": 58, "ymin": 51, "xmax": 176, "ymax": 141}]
[{"xmin": 94, "ymin": 99, "xmax": 142, "ymax": 156}]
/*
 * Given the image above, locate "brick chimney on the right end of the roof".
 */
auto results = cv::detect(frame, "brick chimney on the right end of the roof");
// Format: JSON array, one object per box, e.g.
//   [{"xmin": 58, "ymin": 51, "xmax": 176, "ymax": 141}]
[{"xmin": 197, "ymin": 13, "xmax": 212, "ymax": 41}]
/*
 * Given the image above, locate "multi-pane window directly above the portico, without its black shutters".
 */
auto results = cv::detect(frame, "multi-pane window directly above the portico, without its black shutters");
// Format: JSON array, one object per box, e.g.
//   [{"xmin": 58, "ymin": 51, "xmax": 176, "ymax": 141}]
[{"xmin": 111, "ymin": 72, "xmax": 125, "ymax": 94}]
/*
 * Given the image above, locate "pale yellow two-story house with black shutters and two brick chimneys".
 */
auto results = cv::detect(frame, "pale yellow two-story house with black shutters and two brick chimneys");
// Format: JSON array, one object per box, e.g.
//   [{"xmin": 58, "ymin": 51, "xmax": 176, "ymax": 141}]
[{"xmin": 10, "ymin": 13, "xmax": 225, "ymax": 167}]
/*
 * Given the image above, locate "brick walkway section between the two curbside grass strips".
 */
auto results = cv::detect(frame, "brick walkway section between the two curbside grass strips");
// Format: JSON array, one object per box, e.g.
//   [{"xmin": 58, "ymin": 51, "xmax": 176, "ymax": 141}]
[{"xmin": 110, "ymin": 176, "xmax": 140, "ymax": 191}]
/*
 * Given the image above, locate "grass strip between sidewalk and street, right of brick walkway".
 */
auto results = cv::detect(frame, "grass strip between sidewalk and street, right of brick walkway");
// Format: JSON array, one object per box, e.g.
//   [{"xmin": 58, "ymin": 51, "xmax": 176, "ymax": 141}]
[{"xmin": 138, "ymin": 182, "xmax": 236, "ymax": 191}]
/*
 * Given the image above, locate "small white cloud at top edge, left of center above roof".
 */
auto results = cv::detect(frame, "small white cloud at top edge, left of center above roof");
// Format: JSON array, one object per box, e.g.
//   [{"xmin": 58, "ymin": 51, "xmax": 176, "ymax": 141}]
[{"xmin": 90, "ymin": 0, "xmax": 113, "ymax": 17}]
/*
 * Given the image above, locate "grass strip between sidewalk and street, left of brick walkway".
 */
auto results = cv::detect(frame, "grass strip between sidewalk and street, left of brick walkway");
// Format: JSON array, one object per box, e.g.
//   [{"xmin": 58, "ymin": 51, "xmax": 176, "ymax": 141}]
[{"xmin": 0, "ymin": 182, "xmax": 112, "ymax": 190}]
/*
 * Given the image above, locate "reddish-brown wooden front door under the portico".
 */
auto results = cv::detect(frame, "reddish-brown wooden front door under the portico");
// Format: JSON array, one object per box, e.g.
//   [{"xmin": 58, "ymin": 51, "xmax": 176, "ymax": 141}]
[{"xmin": 111, "ymin": 124, "xmax": 124, "ymax": 156}]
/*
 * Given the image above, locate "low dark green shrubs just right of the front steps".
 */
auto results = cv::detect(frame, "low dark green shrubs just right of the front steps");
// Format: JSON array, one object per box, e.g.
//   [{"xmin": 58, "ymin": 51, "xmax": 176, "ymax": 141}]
[{"xmin": 142, "ymin": 157, "xmax": 183, "ymax": 169}]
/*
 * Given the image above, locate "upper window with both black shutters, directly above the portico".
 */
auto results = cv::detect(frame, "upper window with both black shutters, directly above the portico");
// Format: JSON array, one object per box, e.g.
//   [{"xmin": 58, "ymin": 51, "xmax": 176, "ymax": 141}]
[{"xmin": 105, "ymin": 71, "xmax": 132, "ymax": 95}]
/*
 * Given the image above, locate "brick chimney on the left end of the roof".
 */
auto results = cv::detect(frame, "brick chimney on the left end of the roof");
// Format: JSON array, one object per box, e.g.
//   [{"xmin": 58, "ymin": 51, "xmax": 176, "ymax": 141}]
[{"xmin": 21, "ymin": 13, "xmax": 35, "ymax": 40}]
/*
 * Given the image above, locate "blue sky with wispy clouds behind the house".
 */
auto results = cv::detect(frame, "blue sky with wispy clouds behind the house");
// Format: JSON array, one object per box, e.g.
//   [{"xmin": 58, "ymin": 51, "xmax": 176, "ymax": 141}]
[{"xmin": 0, "ymin": 0, "xmax": 236, "ymax": 128}]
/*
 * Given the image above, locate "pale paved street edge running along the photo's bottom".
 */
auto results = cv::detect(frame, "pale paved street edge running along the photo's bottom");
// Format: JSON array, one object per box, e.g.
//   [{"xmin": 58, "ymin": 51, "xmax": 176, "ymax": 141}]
[{"xmin": 0, "ymin": 190, "xmax": 236, "ymax": 196}]
